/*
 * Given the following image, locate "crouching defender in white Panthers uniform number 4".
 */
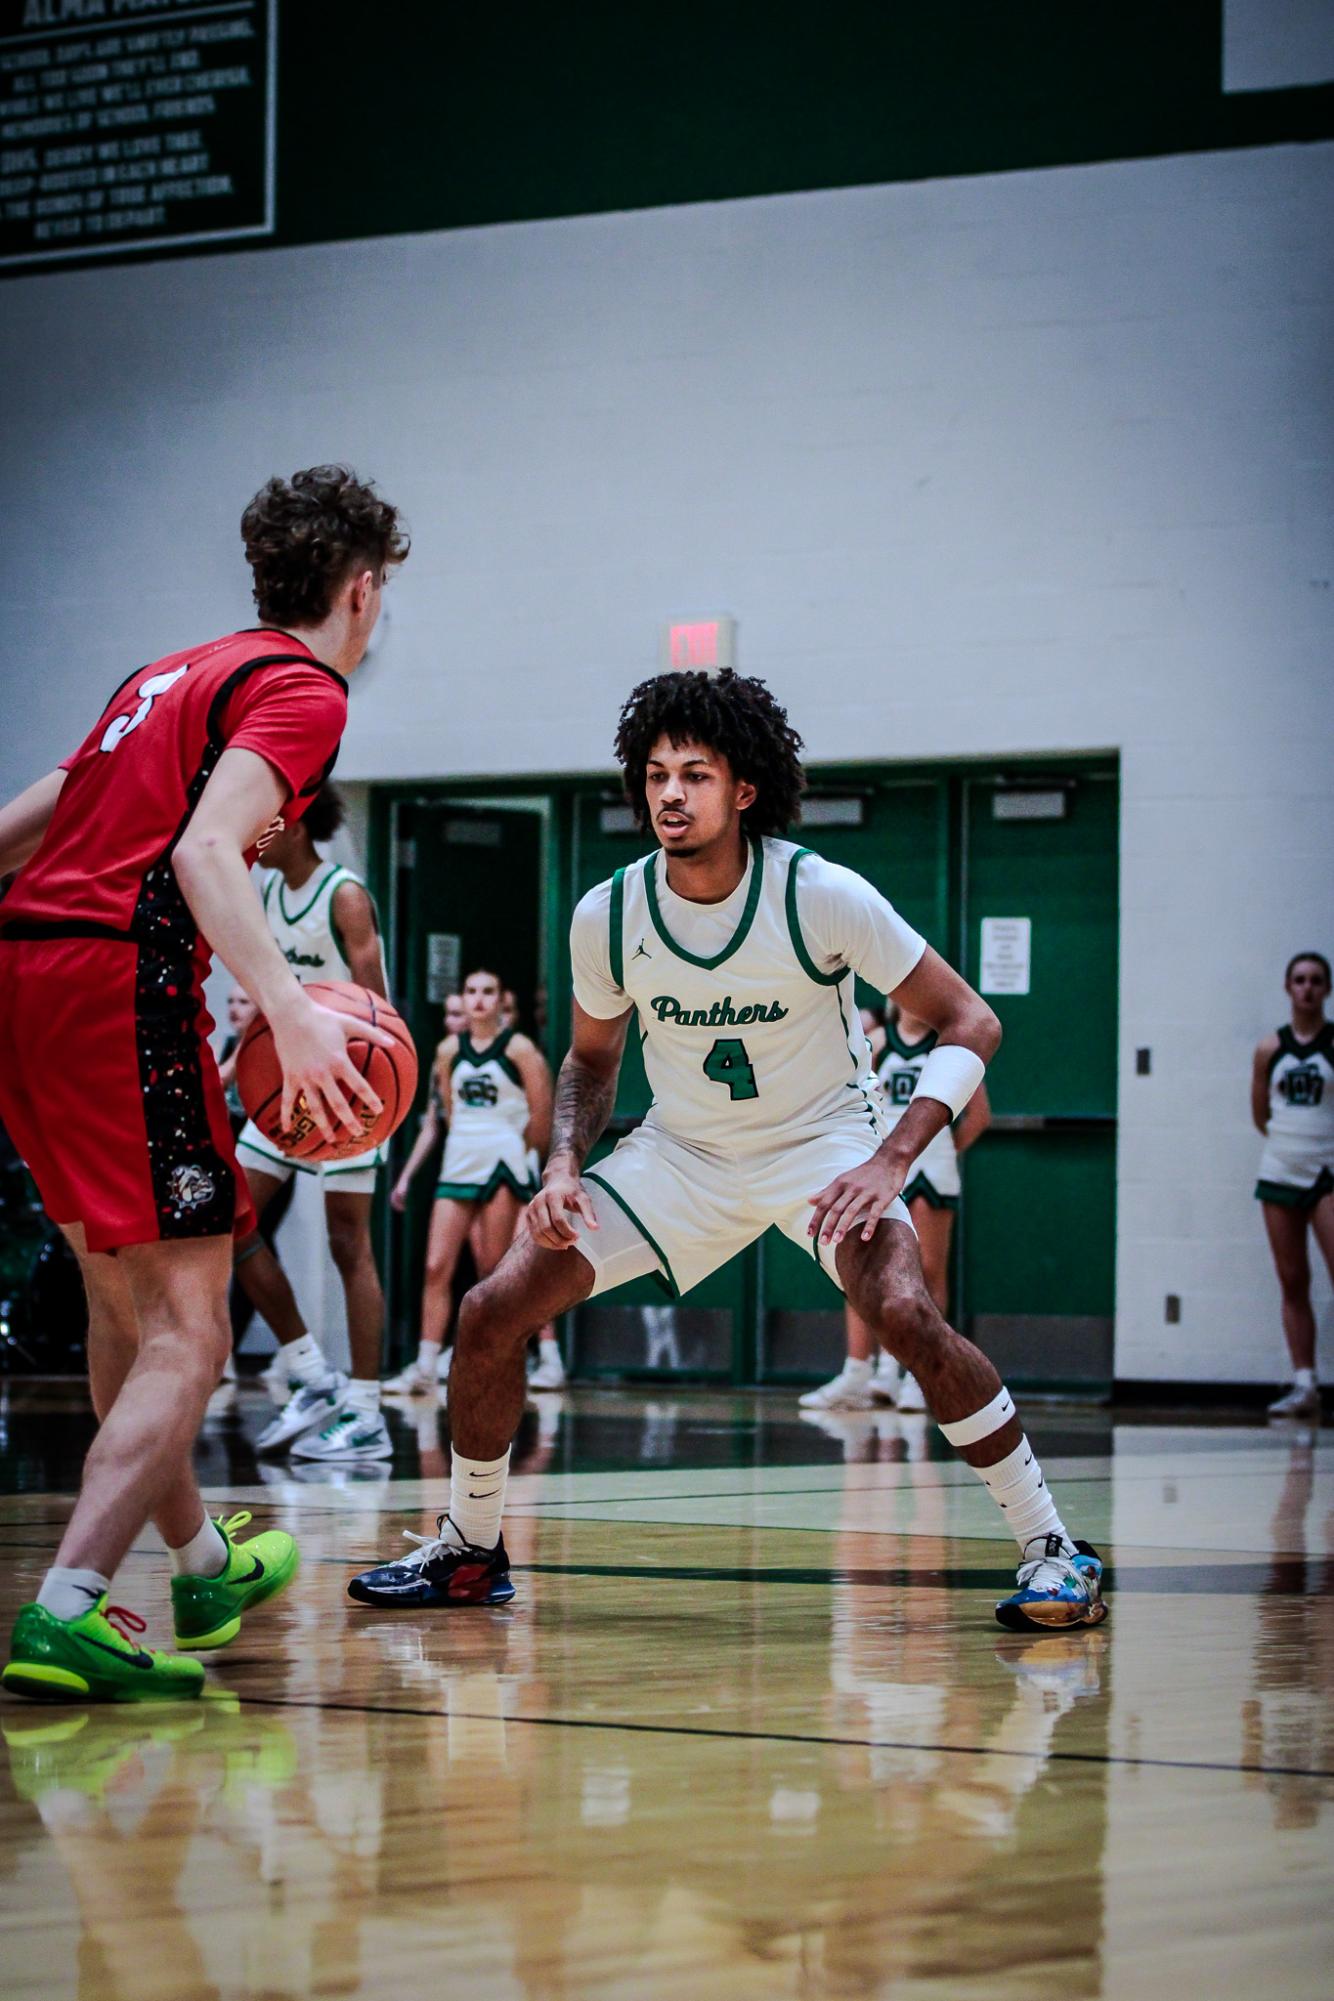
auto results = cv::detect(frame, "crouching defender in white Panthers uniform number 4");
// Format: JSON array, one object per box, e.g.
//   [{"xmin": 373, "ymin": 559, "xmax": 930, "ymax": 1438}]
[{"xmin": 348, "ymin": 672, "xmax": 1106, "ymax": 1631}]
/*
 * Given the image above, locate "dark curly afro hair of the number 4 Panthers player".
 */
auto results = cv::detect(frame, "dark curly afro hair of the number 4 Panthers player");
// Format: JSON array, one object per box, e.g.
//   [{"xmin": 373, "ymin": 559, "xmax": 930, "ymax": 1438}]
[{"xmin": 616, "ymin": 666, "xmax": 806, "ymax": 834}]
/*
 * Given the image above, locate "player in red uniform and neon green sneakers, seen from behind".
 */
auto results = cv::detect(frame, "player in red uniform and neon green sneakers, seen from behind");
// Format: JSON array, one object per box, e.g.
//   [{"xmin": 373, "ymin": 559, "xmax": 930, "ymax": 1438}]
[{"xmin": 0, "ymin": 466, "xmax": 408, "ymax": 1701}]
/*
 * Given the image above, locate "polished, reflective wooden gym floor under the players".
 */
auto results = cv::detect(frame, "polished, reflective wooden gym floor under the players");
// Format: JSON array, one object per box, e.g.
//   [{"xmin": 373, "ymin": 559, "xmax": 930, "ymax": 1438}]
[{"xmin": 0, "ymin": 1383, "xmax": 1334, "ymax": 2001}]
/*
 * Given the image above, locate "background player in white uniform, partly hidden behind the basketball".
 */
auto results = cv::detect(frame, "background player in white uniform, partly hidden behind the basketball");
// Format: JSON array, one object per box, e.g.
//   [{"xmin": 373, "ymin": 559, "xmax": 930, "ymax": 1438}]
[{"xmin": 236, "ymin": 784, "xmax": 392, "ymax": 1463}]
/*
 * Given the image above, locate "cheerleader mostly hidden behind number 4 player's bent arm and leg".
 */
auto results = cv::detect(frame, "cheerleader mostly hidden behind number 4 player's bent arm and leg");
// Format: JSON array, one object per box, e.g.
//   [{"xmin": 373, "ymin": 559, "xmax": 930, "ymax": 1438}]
[{"xmin": 798, "ymin": 1009, "xmax": 992, "ymax": 1413}]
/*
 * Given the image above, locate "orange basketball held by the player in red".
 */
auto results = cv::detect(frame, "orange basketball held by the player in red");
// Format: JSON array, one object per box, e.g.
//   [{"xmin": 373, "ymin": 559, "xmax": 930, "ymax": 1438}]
[{"xmin": 236, "ymin": 980, "xmax": 416, "ymax": 1161}]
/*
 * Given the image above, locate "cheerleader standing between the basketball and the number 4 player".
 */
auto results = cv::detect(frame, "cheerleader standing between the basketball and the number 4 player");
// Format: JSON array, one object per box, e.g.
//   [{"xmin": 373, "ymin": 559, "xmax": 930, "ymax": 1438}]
[{"xmin": 384, "ymin": 968, "xmax": 564, "ymax": 1397}]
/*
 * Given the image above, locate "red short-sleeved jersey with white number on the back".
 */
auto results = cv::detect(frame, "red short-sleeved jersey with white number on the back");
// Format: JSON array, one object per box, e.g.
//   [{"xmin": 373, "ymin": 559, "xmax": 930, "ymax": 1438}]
[{"xmin": 0, "ymin": 628, "xmax": 348, "ymax": 958}]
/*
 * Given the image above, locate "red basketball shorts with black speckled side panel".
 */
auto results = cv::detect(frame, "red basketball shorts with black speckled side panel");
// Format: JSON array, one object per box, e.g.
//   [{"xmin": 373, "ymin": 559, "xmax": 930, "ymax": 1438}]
[{"xmin": 0, "ymin": 936, "xmax": 254, "ymax": 1251}]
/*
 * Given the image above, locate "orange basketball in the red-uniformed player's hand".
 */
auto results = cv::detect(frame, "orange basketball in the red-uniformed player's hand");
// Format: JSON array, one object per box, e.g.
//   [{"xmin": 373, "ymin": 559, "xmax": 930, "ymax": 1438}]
[{"xmin": 236, "ymin": 980, "xmax": 416, "ymax": 1161}]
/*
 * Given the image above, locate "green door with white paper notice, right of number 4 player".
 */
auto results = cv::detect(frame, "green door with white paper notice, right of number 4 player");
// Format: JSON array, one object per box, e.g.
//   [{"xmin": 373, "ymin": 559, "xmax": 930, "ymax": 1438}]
[{"xmin": 960, "ymin": 770, "xmax": 1118, "ymax": 1393}]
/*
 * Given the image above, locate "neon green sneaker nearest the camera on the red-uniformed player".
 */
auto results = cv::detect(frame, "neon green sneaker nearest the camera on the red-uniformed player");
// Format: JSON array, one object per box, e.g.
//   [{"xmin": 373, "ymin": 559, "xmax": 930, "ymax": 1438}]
[{"xmin": 0, "ymin": 1593, "xmax": 204, "ymax": 1703}]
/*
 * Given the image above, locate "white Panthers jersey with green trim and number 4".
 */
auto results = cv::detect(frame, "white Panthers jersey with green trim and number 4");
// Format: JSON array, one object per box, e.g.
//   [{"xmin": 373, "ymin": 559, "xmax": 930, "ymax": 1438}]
[{"xmin": 570, "ymin": 838, "xmax": 926, "ymax": 1157}]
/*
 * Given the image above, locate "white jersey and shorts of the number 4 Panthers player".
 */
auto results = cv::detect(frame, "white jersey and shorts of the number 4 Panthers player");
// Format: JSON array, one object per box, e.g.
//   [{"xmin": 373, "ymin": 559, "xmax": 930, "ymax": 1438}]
[{"xmin": 570, "ymin": 840, "xmax": 926, "ymax": 1295}]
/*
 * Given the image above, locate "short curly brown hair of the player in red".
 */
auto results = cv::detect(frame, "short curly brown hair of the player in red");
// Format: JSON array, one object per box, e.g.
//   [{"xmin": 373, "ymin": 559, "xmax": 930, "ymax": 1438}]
[{"xmin": 240, "ymin": 466, "xmax": 408, "ymax": 626}]
